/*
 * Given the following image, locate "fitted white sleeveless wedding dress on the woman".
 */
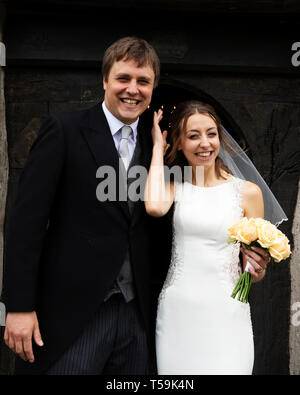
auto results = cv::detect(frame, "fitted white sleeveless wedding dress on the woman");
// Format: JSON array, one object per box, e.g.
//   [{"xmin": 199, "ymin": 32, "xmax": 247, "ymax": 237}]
[{"xmin": 156, "ymin": 177, "xmax": 254, "ymax": 375}]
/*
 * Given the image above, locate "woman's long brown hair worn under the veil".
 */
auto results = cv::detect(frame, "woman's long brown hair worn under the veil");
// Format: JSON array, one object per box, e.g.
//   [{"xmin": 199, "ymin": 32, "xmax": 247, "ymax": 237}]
[{"xmin": 166, "ymin": 100, "xmax": 232, "ymax": 178}]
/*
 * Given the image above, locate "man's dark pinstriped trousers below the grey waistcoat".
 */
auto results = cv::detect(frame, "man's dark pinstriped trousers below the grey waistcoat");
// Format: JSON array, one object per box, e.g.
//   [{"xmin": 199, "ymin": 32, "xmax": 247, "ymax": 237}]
[{"xmin": 46, "ymin": 294, "xmax": 148, "ymax": 375}]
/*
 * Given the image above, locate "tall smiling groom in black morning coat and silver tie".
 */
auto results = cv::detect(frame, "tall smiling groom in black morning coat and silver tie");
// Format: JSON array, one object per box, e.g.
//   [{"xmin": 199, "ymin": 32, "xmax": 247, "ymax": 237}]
[{"xmin": 3, "ymin": 37, "xmax": 160, "ymax": 374}]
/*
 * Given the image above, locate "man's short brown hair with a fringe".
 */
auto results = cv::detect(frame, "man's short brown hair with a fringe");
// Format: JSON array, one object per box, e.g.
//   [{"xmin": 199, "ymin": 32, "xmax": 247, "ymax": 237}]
[{"xmin": 102, "ymin": 37, "xmax": 160, "ymax": 87}]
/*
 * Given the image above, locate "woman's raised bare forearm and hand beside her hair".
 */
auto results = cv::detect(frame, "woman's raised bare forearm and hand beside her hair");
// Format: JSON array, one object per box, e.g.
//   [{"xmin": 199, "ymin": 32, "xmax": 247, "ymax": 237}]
[{"xmin": 145, "ymin": 110, "xmax": 174, "ymax": 217}]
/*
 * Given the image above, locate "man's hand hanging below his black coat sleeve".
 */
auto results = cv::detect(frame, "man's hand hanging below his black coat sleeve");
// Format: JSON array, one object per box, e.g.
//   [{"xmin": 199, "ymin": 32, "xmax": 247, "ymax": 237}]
[{"xmin": 4, "ymin": 311, "xmax": 44, "ymax": 363}]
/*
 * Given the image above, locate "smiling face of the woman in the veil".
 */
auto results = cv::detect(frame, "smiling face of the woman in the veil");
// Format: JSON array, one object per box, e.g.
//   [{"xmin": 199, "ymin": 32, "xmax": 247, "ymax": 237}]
[{"xmin": 178, "ymin": 114, "xmax": 220, "ymax": 168}]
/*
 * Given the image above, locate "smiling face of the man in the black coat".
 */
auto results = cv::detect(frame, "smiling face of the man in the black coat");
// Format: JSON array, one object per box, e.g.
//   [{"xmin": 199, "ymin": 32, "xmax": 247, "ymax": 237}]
[{"xmin": 103, "ymin": 60, "xmax": 155, "ymax": 124}]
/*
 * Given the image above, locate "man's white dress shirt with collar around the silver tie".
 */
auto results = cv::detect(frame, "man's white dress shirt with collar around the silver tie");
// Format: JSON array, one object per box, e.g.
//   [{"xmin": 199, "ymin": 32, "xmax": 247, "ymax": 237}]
[{"xmin": 102, "ymin": 101, "xmax": 139, "ymax": 166}]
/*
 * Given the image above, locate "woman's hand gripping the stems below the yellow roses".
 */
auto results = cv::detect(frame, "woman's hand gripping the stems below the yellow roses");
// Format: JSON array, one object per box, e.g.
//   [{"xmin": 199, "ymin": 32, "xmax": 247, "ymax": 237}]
[{"xmin": 241, "ymin": 247, "xmax": 271, "ymax": 282}]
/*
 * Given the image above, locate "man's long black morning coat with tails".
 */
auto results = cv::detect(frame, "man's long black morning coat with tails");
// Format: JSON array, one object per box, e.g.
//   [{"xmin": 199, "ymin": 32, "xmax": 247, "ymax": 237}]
[{"xmin": 3, "ymin": 104, "xmax": 164, "ymax": 374}]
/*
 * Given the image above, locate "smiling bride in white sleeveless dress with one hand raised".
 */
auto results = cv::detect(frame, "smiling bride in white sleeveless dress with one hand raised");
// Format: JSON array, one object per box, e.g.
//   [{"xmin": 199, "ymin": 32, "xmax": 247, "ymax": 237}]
[{"xmin": 145, "ymin": 101, "xmax": 269, "ymax": 375}]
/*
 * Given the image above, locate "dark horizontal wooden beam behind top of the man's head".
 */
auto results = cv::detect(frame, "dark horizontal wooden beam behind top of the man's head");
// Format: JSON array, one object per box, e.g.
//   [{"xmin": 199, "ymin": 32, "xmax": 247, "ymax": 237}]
[{"xmin": 6, "ymin": 8, "xmax": 298, "ymax": 73}]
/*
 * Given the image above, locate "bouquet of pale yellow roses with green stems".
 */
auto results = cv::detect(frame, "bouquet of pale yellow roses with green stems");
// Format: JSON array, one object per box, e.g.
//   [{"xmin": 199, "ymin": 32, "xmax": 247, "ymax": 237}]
[{"xmin": 228, "ymin": 217, "xmax": 291, "ymax": 303}]
